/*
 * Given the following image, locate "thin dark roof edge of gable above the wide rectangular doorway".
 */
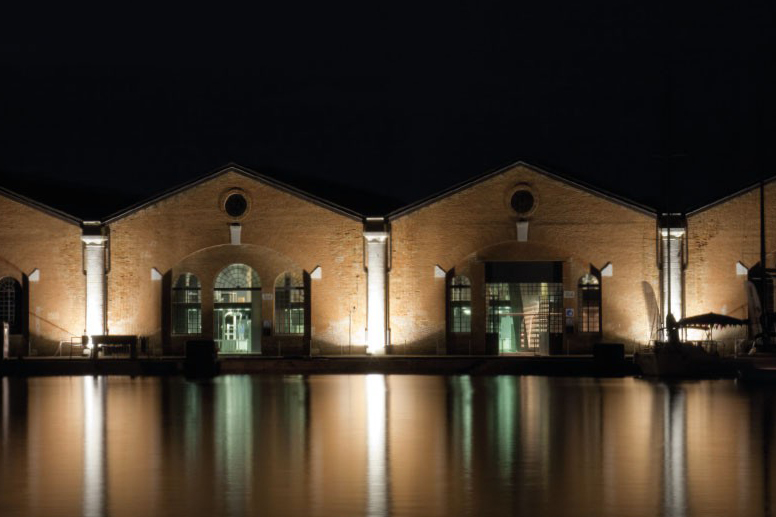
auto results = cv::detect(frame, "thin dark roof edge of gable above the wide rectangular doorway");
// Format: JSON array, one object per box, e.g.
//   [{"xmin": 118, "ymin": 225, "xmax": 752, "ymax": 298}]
[{"xmin": 387, "ymin": 161, "xmax": 657, "ymax": 220}]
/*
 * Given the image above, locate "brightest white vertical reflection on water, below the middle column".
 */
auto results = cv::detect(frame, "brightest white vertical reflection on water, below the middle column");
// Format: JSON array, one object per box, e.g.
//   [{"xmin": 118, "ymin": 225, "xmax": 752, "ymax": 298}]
[{"xmin": 366, "ymin": 374, "xmax": 388, "ymax": 516}]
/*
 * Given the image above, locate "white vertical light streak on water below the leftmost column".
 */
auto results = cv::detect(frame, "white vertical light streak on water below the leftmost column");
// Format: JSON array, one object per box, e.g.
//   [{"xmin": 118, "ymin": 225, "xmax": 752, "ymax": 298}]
[{"xmin": 83, "ymin": 377, "xmax": 105, "ymax": 517}]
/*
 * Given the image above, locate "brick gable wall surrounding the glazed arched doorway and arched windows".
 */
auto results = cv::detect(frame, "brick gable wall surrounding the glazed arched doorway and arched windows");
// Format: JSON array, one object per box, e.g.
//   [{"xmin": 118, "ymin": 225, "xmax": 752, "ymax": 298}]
[{"xmin": 108, "ymin": 171, "xmax": 366, "ymax": 353}]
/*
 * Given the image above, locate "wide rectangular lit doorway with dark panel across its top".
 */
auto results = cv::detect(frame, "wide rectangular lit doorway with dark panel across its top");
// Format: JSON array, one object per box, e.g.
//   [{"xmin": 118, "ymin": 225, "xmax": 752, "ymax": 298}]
[{"xmin": 485, "ymin": 262, "xmax": 563, "ymax": 354}]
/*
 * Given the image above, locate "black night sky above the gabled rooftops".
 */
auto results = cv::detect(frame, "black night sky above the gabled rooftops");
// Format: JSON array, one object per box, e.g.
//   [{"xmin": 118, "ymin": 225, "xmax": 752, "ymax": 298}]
[{"xmin": 0, "ymin": 1, "xmax": 776, "ymax": 218}]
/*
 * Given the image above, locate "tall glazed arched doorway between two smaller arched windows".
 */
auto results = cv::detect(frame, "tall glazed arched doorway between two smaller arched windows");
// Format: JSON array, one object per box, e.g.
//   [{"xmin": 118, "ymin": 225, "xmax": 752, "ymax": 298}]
[{"xmin": 213, "ymin": 264, "xmax": 261, "ymax": 354}]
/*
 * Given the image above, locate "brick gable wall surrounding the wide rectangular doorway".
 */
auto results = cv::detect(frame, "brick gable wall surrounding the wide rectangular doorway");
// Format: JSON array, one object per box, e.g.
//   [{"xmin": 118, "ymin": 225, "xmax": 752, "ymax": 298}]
[{"xmin": 389, "ymin": 165, "xmax": 658, "ymax": 353}]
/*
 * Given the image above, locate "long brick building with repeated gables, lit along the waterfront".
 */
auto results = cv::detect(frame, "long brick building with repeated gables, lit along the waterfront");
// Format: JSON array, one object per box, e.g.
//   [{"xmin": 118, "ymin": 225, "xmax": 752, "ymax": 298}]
[{"xmin": 0, "ymin": 163, "xmax": 776, "ymax": 355}]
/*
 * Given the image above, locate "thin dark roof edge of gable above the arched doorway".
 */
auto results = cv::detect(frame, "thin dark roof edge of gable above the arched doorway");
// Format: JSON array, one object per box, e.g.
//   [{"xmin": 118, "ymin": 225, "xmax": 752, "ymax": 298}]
[{"xmin": 103, "ymin": 163, "xmax": 364, "ymax": 224}]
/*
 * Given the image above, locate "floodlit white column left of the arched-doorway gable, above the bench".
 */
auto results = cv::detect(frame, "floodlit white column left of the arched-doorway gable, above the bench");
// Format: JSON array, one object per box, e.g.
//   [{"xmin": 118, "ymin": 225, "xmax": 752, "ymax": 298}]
[{"xmin": 81, "ymin": 235, "xmax": 108, "ymax": 336}]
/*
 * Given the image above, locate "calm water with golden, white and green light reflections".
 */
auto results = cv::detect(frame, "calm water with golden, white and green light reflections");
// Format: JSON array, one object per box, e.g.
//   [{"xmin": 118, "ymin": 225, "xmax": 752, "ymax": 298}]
[{"xmin": 0, "ymin": 375, "xmax": 776, "ymax": 517}]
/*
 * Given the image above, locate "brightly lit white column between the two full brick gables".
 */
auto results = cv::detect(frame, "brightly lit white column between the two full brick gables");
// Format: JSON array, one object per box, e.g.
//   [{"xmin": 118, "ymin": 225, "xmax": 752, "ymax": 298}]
[{"xmin": 364, "ymin": 231, "xmax": 388, "ymax": 354}]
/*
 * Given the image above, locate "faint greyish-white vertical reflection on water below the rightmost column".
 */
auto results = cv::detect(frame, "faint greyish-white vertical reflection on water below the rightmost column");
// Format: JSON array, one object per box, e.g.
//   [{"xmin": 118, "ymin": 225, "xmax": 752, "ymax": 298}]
[{"xmin": 663, "ymin": 388, "xmax": 687, "ymax": 516}]
